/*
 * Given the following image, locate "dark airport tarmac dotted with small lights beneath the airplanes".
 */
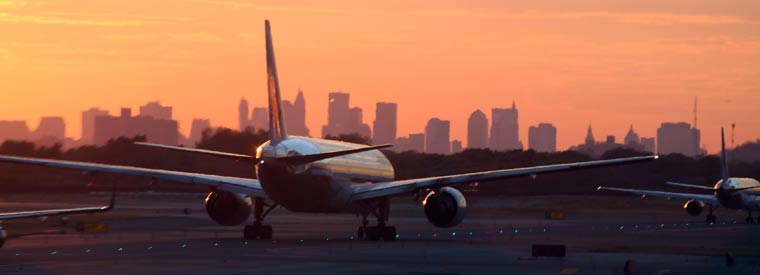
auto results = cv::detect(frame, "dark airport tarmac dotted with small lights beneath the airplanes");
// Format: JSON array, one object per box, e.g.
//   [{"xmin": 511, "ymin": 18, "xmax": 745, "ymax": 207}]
[{"xmin": 0, "ymin": 196, "xmax": 760, "ymax": 274}]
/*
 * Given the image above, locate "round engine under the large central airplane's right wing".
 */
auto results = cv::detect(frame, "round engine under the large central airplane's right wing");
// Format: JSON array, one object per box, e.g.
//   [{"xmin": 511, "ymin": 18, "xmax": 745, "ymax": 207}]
[{"xmin": 422, "ymin": 187, "xmax": 467, "ymax": 227}]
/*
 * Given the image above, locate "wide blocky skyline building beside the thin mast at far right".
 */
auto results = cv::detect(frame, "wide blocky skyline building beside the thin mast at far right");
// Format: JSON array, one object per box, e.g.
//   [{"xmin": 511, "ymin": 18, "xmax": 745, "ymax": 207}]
[{"xmin": 657, "ymin": 122, "xmax": 704, "ymax": 157}]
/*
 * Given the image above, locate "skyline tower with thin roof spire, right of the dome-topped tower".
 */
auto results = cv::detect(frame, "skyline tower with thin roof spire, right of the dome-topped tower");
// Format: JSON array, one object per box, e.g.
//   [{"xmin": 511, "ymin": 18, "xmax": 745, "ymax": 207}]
[{"xmin": 489, "ymin": 102, "xmax": 523, "ymax": 151}]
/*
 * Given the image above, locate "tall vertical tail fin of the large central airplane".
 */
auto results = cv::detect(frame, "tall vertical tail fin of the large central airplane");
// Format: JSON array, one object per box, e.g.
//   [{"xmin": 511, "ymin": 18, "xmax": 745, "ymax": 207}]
[{"xmin": 264, "ymin": 20, "xmax": 288, "ymax": 144}]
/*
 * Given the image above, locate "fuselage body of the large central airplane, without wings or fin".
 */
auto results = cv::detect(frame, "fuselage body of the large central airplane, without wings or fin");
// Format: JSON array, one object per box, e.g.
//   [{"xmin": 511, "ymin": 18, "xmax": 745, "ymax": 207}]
[{"xmin": 256, "ymin": 136, "xmax": 394, "ymax": 213}]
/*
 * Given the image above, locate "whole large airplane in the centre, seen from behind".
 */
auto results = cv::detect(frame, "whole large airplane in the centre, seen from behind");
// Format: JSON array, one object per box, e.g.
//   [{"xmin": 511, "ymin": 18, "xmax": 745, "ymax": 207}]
[{"xmin": 0, "ymin": 20, "xmax": 657, "ymax": 241}]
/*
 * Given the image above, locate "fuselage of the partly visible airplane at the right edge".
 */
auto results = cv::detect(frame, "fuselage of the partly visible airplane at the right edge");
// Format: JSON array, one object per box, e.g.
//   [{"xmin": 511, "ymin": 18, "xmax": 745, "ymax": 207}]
[{"xmin": 713, "ymin": 178, "xmax": 760, "ymax": 210}]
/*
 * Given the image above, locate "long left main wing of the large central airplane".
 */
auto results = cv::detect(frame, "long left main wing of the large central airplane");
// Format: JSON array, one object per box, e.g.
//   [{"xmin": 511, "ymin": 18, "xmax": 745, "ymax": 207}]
[{"xmin": 0, "ymin": 155, "xmax": 267, "ymax": 198}]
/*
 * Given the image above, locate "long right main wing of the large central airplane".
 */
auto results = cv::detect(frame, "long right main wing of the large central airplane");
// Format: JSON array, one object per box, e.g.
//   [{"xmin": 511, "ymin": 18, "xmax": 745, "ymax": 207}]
[{"xmin": 351, "ymin": 156, "xmax": 657, "ymax": 201}]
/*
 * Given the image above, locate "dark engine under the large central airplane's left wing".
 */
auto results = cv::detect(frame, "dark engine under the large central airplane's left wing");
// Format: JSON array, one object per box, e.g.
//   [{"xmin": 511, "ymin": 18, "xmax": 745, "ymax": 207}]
[{"xmin": 206, "ymin": 191, "xmax": 253, "ymax": 226}]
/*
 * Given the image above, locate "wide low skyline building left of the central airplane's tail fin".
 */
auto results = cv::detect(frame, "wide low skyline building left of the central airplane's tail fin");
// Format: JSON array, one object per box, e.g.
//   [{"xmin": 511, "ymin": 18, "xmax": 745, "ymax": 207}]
[{"xmin": 95, "ymin": 108, "xmax": 179, "ymax": 146}]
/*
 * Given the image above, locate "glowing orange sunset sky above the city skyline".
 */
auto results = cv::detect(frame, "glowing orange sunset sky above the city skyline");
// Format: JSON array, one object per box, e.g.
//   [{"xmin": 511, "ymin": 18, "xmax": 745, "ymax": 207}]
[{"xmin": 0, "ymin": 0, "xmax": 760, "ymax": 152}]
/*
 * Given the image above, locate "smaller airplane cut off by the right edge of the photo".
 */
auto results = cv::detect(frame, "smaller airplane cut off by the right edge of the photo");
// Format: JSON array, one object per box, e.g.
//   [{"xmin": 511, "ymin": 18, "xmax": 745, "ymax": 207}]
[{"xmin": 598, "ymin": 127, "xmax": 760, "ymax": 223}]
